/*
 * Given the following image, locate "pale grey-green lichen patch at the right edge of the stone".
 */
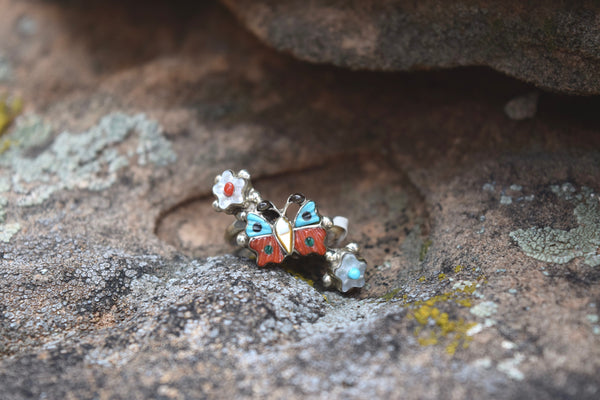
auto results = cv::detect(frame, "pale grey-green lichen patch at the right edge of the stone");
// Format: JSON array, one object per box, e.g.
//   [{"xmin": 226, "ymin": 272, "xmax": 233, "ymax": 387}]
[{"xmin": 510, "ymin": 183, "xmax": 600, "ymax": 267}]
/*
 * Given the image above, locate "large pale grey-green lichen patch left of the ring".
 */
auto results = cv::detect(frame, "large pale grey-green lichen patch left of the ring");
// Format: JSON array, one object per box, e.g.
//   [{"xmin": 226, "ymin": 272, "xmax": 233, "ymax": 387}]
[{"xmin": 0, "ymin": 113, "xmax": 175, "ymax": 206}]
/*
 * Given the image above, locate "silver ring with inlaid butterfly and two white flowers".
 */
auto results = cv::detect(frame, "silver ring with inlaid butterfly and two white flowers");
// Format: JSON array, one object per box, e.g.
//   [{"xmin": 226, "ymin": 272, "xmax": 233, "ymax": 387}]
[{"xmin": 213, "ymin": 170, "xmax": 367, "ymax": 293}]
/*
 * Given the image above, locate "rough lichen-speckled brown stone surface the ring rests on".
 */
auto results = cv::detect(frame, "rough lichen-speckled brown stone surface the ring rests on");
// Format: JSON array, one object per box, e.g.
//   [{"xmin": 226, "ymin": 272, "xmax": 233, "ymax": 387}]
[{"xmin": 0, "ymin": 0, "xmax": 600, "ymax": 399}]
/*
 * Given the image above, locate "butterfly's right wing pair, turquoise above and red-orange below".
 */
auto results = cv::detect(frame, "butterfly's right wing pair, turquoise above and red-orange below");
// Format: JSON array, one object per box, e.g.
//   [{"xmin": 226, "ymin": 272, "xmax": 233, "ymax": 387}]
[{"xmin": 294, "ymin": 200, "xmax": 327, "ymax": 256}]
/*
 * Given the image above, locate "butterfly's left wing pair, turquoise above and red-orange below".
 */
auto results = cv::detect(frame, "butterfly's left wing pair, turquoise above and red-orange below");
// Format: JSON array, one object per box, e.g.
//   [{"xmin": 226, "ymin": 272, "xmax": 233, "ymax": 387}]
[{"xmin": 246, "ymin": 213, "xmax": 284, "ymax": 267}]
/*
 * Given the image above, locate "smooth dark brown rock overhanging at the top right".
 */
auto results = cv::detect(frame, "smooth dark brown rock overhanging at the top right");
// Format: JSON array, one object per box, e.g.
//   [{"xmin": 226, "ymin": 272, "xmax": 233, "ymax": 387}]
[{"xmin": 223, "ymin": 0, "xmax": 600, "ymax": 95}]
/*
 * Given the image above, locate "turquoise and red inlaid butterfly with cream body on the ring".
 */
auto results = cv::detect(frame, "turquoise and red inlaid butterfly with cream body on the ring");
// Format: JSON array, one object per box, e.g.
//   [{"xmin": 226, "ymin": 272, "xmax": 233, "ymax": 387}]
[{"xmin": 246, "ymin": 200, "xmax": 327, "ymax": 267}]
